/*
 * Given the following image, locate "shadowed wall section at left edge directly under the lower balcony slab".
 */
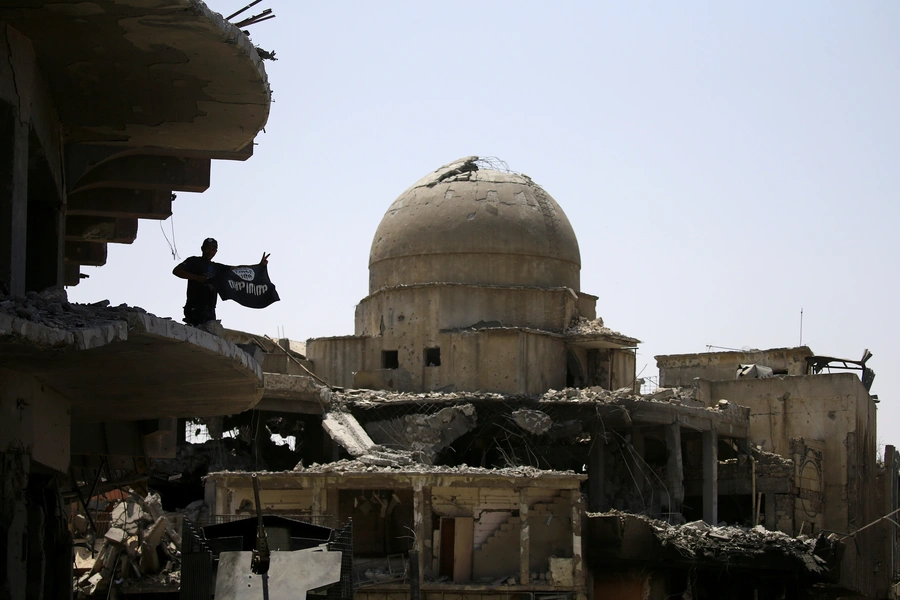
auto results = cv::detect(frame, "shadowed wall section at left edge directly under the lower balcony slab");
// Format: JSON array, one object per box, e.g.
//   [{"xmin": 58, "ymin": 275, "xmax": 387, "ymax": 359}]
[{"xmin": 0, "ymin": 368, "xmax": 71, "ymax": 473}]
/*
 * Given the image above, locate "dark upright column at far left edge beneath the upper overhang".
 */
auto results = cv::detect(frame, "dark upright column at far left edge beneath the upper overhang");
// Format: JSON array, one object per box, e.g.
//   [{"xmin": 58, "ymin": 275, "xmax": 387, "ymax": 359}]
[{"xmin": 0, "ymin": 102, "xmax": 28, "ymax": 296}]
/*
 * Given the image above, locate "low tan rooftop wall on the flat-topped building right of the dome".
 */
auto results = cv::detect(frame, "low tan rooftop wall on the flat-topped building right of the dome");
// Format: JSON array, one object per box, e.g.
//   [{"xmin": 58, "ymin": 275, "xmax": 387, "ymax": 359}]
[{"xmin": 655, "ymin": 346, "xmax": 813, "ymax": 387}]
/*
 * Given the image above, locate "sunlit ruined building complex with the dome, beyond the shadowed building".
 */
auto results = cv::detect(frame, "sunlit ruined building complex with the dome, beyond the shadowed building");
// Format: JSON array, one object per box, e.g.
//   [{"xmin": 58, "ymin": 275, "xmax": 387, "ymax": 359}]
[{"xmin": 82, "ymin": 157, "xmax": 884, "ymax": 600}]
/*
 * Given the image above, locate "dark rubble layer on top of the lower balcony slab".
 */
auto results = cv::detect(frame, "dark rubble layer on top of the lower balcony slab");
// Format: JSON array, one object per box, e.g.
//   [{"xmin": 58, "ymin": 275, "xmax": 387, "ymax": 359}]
[{"xmin": 0, "ymin": 286, "xmax": 155, "ymax": 330}]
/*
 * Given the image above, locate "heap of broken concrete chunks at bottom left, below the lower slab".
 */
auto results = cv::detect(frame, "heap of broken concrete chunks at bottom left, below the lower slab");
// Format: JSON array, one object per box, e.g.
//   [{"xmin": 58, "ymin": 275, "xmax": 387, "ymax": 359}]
[{"xmin": 73, "ymin": 493, "xmax": 200, "ymax": 598}]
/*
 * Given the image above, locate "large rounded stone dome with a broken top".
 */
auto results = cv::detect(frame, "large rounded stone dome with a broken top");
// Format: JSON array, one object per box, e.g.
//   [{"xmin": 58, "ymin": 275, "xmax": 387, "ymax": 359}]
[{"xmin": 369, "ymin": 156, "xmax": 581, "ymax": 294}]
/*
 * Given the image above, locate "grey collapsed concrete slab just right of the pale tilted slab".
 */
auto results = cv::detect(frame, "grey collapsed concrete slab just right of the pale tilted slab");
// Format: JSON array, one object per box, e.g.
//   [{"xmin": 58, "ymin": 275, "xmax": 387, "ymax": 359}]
[{"xmin": 364, "ymin": 404, "xmax": 477, "ymax": 464}]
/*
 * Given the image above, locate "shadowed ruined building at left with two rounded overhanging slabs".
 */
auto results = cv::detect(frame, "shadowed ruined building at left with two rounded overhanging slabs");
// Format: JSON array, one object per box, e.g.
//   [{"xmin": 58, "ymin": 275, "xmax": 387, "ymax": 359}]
[{"xmin": 0, "ymin": 0, "xmax": 271, "ymax": 599}]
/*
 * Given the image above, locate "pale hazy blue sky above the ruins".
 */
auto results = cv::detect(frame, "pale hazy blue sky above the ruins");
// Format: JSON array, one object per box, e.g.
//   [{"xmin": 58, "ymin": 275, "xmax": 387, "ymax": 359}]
[{"xmin": 69, "ymin": 0, "xmax": 900, "ymax": 444}]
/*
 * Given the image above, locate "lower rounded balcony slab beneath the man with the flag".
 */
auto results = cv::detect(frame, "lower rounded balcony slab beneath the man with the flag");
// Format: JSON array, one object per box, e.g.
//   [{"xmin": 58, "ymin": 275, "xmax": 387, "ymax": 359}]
[{"xmin": 0, "ymin": 311, "xmax": 263, "ymax": 423}]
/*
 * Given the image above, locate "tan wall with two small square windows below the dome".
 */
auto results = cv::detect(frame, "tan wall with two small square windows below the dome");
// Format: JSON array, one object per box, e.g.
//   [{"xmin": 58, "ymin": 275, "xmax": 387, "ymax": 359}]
[{"xmin": 307, "ymin": 328, "xmax": 566, "ymax": 394}]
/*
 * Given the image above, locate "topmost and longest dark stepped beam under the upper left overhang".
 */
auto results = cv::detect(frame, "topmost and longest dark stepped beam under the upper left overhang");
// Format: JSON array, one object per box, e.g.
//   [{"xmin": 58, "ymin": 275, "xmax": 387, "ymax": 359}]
[{"xmin": 69, "ymin": 156, "xmax": 210, "ymax": 193}]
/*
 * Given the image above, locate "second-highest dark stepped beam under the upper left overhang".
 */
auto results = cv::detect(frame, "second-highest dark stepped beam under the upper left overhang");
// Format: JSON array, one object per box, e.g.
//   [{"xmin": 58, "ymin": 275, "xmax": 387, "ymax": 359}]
[{"xmin": 66, "ymin": 188, "xmax": 172, "ymax": 221}]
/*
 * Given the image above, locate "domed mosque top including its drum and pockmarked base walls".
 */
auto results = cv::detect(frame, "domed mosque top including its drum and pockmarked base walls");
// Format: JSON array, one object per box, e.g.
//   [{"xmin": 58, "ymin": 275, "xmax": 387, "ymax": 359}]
[{"xmin": 307, "ymin": 156, "xmax": 638, "ymax": 394}]
